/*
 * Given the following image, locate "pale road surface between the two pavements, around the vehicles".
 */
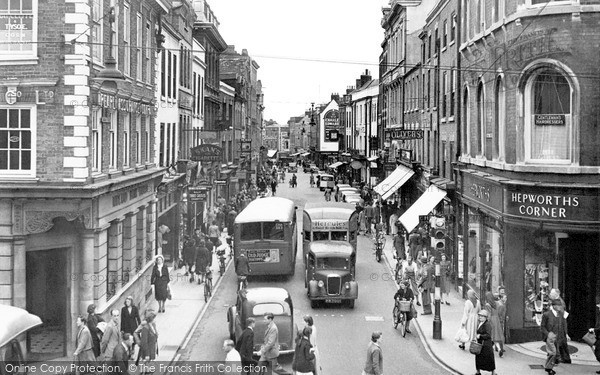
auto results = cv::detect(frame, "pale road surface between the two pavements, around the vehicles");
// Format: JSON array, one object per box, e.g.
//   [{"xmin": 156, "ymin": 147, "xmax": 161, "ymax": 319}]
[{"xmin": 179, "ymin": 171, "xmax": 445, "ymax": 375}]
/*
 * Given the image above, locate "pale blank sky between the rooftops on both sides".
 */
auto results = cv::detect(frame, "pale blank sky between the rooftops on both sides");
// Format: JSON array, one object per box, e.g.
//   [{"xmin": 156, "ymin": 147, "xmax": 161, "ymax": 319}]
[{"xmin": 208, "ymin": 0, "xmax": 388, "ymax": 124}]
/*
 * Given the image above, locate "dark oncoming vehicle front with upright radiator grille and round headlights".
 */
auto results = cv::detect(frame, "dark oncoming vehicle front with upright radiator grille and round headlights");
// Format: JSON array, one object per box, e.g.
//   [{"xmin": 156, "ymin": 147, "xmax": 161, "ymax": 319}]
[{"xmin": 304, "ymin": 241, "xmax": 358, "ymax": 308}]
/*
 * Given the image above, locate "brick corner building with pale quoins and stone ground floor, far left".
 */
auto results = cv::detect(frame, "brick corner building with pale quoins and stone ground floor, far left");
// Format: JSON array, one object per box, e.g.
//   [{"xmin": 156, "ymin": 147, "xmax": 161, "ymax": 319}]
[{"xmin": 0, "ymin": 0, "xmax": 171, "ymax": 359}]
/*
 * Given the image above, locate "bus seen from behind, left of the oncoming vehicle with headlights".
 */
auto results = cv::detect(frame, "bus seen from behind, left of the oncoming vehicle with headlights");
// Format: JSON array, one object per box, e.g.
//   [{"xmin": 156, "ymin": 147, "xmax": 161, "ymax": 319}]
[{"xmin": 233, "ymin": 197, "xmax": 297, "ymax": 276}]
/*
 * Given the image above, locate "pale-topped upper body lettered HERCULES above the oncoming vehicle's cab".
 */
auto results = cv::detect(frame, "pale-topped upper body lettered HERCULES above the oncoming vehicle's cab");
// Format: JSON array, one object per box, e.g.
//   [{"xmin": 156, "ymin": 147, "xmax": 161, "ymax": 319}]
[{"xmin": 302, "ymin": 202, "xmax": 358, "ymax": 262}]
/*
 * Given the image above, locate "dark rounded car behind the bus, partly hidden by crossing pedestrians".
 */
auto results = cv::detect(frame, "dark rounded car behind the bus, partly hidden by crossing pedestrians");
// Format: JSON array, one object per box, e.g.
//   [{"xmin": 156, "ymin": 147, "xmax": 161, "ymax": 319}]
[{"xmin": 227, "ymin": 288, "xmax": 298, "ymax": 355}]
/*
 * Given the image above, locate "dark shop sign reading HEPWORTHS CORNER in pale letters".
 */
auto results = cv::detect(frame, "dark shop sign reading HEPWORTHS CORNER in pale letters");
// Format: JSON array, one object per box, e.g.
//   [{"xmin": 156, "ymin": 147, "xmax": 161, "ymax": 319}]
[{"xmin": 505, "ymin": 187, "xmax": 600, "ymax": 222}]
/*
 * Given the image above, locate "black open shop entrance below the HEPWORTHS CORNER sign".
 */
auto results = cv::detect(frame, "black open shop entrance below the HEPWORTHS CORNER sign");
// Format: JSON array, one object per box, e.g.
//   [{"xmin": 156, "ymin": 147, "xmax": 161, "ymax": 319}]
[{"xmin": 559, "ymin": 233, "xmax": 599, "ymax": 340}]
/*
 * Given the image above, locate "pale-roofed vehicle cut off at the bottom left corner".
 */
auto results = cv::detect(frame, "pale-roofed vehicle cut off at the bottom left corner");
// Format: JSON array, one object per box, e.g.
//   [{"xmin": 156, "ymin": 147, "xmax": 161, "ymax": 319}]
[{"xmin": 0, "ymin": 305, "xmax": 42, "ymax": 374}]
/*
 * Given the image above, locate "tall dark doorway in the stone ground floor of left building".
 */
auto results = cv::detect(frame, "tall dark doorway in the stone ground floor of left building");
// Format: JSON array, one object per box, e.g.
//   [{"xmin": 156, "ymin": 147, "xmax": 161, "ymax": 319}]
[{"xmin": 25, "ymin": 249, "xmax": 69, "ymax": 361}]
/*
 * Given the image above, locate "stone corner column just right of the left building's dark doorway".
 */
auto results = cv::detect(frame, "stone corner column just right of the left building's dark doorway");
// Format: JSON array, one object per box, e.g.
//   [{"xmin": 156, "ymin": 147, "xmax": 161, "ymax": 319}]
[{"xmin": 80, "ymin": 231, "xmax": 97, "ymax": 314}]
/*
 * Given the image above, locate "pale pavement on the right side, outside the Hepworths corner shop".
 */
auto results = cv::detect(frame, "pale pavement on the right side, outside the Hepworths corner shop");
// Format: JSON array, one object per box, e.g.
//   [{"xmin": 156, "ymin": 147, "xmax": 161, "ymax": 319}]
[{"xmin": 384, "ymin": 236, "xmax": 600, "ymax": 375}]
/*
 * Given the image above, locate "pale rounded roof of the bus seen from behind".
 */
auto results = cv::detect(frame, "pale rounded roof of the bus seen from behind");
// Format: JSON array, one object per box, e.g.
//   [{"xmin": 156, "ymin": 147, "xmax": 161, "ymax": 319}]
[{"xmin": 235, "ymin": 197, "xmax": 296, "ymax": 223}]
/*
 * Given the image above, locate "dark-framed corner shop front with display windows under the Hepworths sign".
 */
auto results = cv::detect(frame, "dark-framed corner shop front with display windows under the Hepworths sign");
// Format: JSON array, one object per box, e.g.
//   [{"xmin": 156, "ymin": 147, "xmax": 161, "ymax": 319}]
[{"xmin": 457, "ymin": 170, "xmax": 600, "ymax": 343}]
